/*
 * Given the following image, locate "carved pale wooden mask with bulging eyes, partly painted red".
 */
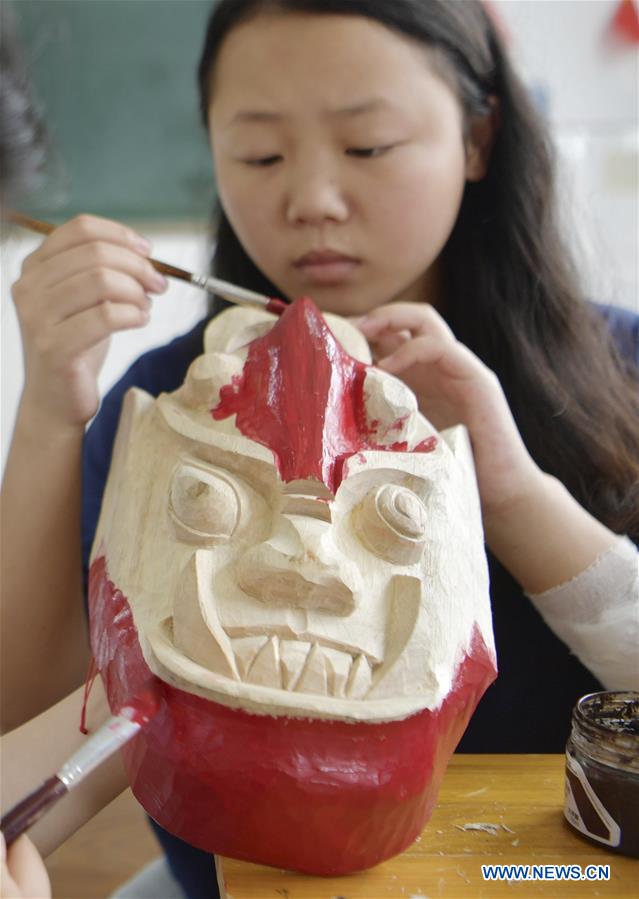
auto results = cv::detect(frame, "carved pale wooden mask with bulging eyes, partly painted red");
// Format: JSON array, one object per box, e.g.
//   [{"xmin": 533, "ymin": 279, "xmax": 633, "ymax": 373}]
[{"xmin": 91, "ymin": 300, "xmax": 495, "ymax": 873}]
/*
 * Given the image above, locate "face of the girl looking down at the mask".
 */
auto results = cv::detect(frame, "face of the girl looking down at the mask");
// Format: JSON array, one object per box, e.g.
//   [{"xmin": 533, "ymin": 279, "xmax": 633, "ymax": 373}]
[{"xmin": 209, "ymin": 14, "xmax": 474, "ymax": 315}]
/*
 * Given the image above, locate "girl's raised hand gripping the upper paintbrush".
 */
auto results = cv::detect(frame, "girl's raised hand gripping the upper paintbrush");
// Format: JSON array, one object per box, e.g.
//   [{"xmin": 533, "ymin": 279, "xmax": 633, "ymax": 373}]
[{"xmin": 13, "ymin": 215, "xmax": 166, "ymax": 428}]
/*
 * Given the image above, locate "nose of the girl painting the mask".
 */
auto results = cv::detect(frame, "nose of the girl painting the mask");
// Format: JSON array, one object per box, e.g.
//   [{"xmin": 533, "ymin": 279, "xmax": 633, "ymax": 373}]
[{"xmin": 286, "ymin": 167, "xmax": 349, "ymax": 225}]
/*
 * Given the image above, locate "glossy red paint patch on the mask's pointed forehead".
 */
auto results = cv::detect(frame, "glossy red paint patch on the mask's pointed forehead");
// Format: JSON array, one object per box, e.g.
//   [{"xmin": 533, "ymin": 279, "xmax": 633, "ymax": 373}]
[{"xmin": 211, "ymin": 297, "xmax": 433, "ymax": 494}]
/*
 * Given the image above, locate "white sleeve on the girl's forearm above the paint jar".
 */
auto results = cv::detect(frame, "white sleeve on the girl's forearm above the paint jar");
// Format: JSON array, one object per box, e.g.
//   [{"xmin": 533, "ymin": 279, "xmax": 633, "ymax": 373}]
[{"xmin": 529, "ymin": 537, "xmax": 639, "ymax": 690}]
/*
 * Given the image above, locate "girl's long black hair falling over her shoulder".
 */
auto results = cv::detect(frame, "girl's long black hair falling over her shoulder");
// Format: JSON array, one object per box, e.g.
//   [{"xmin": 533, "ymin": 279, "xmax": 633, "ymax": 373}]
[{"xmin": 198, "ymin": 0, "xmax": 639, "ymax": 540}]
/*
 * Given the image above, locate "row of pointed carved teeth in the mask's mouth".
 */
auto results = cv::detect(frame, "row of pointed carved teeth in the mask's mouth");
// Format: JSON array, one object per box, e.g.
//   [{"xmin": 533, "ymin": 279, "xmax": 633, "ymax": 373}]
[{"xmin": 230, "ymin": 634, "xmax": 373, "ymax": 699}]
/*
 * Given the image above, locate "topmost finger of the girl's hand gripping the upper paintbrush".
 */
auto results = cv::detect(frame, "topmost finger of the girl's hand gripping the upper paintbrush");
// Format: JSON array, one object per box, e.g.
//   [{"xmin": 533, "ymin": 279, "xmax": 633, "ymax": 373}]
[{"xmin": 22, "ymin": 215, "xmax": 151, "ymax": 272}]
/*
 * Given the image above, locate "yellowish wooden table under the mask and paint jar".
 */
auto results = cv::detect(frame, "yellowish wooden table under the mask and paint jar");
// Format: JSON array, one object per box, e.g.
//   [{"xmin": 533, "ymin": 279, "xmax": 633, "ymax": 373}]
[{"xmin": 219, "ymin": 755, "xmax": 639, "ymax": 899}]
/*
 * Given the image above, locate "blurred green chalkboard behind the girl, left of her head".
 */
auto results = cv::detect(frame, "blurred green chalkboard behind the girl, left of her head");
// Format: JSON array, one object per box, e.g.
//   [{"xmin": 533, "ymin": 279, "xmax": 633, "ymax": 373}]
[{"xmin": 10, "ymin": 0, "xmax": 214, "ymax": 221}]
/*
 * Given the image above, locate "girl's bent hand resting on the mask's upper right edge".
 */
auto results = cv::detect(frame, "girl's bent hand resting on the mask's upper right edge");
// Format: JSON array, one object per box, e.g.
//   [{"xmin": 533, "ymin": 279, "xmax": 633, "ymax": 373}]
[{"xmin": 355, "ymin": 303, "xmax": 543, "ymax": 516}]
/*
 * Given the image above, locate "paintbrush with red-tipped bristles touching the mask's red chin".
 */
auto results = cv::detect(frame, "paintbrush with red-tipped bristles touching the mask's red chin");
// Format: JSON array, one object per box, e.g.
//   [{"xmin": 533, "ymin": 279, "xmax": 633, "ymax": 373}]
[{"xmin": 0, "ymin": 681, "xmax": 160, "ymax": 846}]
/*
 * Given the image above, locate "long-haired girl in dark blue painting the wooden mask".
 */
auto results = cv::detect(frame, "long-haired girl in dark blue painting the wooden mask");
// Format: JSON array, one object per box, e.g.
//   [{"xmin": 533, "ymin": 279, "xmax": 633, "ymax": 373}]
[{"xmin": 3, "ymin": 0, "xmax": 639, "ymax": 896}]
